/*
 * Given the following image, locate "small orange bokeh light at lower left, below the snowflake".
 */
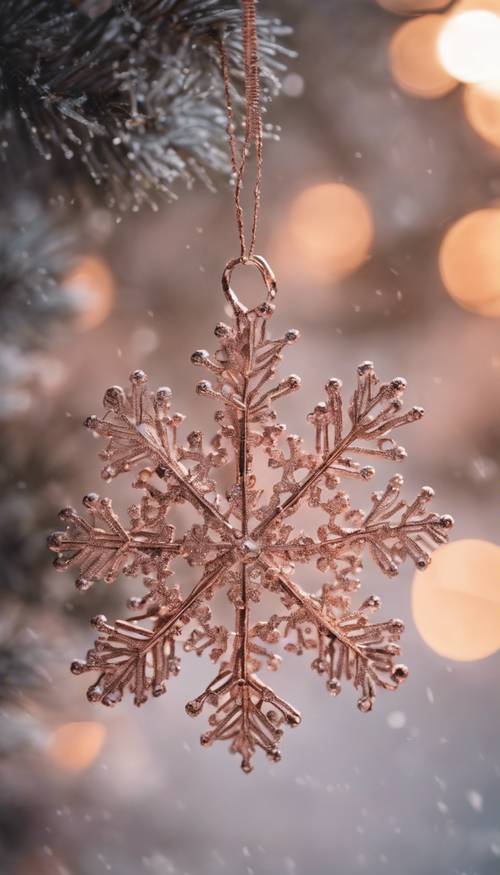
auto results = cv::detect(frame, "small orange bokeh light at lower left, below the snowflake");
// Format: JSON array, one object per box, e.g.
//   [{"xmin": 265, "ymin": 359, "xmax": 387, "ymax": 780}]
[{"xmin": 48, "ymin": 722, "xmax": 106, "ymax": 772}]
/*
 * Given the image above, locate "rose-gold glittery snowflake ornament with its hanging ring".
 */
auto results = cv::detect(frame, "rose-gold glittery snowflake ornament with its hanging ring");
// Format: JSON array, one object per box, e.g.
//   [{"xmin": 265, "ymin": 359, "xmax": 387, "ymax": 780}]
[{"xmin": 49, "ymin": 256, "xmax": 452, "ymax": 772}]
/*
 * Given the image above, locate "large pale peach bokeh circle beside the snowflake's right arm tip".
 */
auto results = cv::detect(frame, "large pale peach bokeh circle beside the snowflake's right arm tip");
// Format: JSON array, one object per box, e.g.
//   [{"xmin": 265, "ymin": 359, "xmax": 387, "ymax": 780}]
[{"xmin": 412, "ymin": 540, "xmax": 500, "ymax": 661}]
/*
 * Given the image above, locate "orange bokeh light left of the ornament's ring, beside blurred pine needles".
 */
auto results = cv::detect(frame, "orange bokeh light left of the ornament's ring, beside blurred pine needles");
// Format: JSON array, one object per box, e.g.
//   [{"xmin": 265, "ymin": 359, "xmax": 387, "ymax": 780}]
[{"xmin": 64, "ymin": 255, "xmax": 115, "ymax": 331}]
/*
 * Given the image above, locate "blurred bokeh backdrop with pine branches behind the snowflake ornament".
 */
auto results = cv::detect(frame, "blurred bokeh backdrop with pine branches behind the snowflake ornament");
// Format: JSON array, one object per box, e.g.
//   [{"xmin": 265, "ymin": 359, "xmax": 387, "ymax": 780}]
[{"xmin": 0, "ymin": 0, "xmax": 500, "ymax": 875}]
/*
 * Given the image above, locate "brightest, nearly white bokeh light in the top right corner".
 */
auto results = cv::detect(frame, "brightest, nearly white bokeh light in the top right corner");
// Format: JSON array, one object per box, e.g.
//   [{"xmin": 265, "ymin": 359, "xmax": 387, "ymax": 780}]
[{"xmin": 437, "ymin": 8, "xmax": 500, "ymax": 82}]
